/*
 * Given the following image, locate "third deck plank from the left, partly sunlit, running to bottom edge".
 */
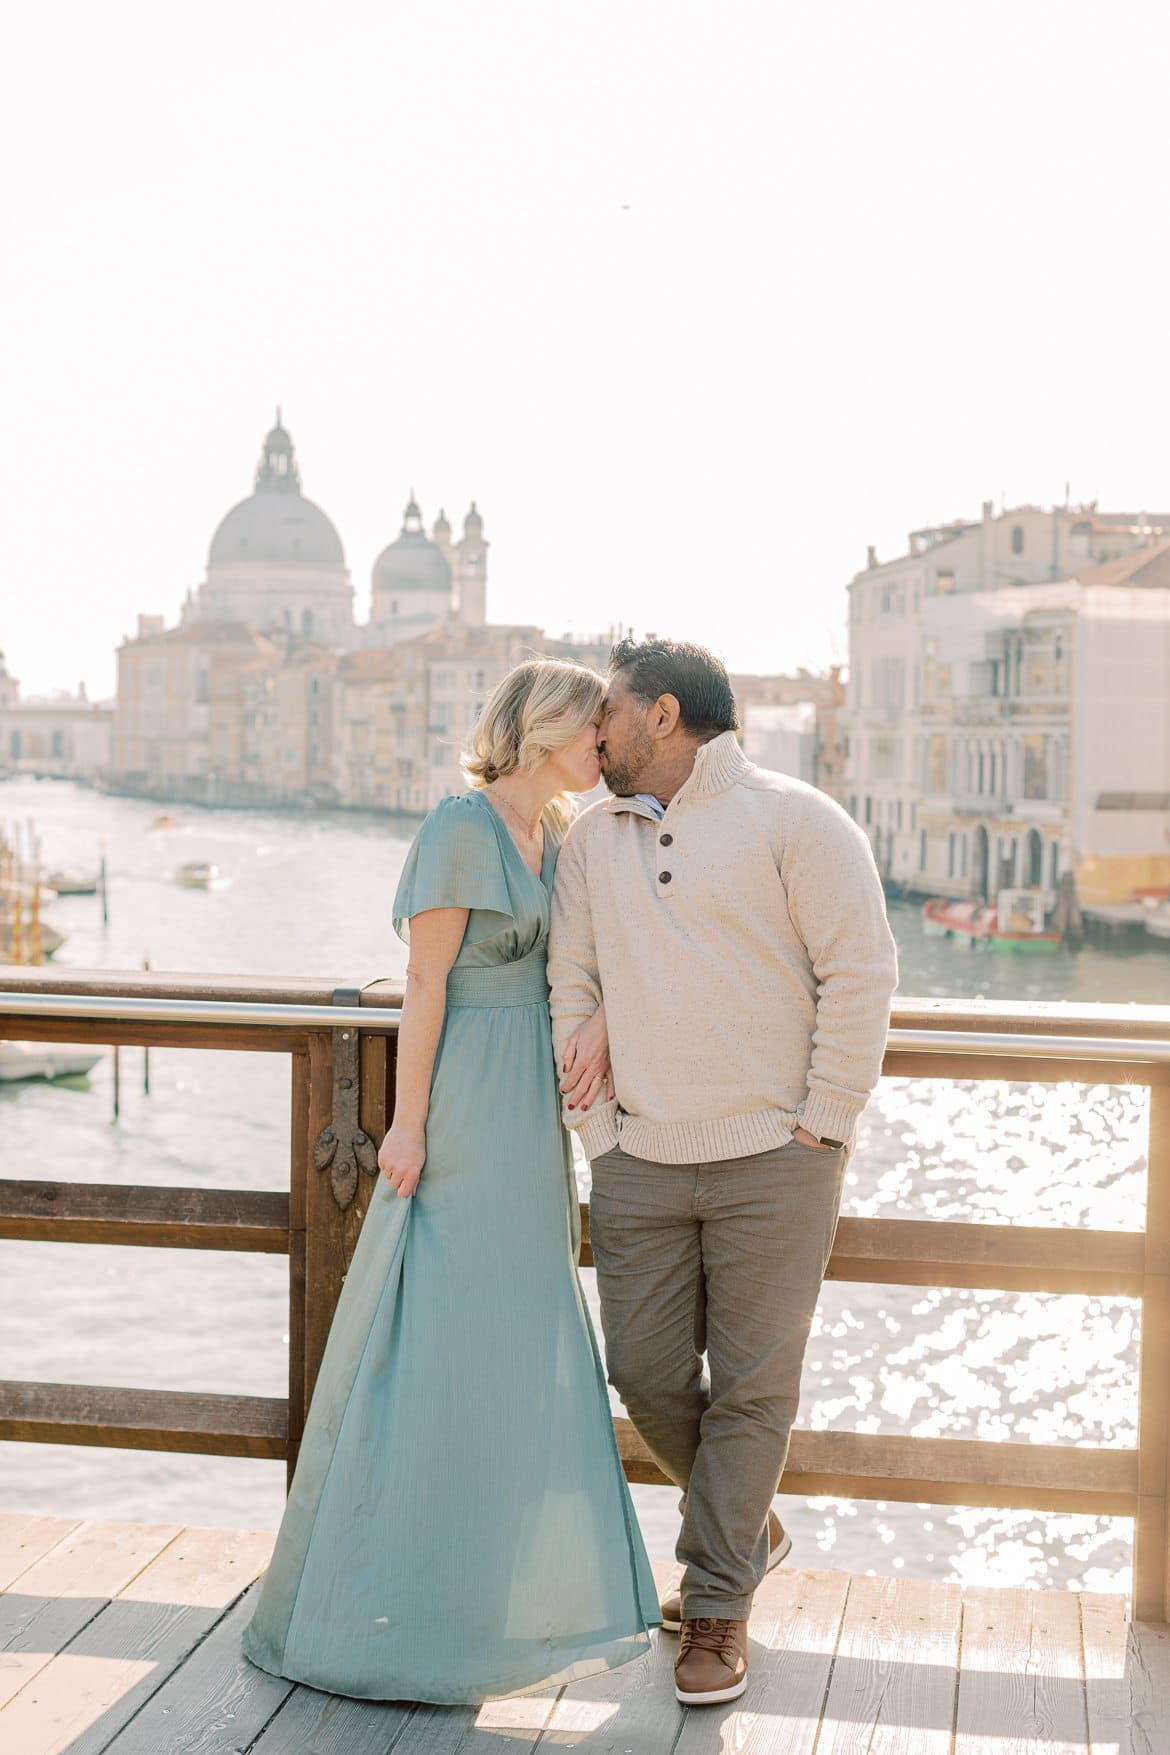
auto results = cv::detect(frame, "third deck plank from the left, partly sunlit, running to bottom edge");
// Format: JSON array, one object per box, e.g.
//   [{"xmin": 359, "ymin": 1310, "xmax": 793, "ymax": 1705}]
[{"xmin": 0, "ymin": 1530, "xmax": 274, "ymax": 1755}]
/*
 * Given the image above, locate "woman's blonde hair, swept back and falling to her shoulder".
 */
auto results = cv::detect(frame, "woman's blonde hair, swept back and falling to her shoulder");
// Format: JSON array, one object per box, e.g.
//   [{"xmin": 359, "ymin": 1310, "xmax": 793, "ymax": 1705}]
[{"xmin": 463, "ymin": 658, "xmax": 605, "ymax": 832}]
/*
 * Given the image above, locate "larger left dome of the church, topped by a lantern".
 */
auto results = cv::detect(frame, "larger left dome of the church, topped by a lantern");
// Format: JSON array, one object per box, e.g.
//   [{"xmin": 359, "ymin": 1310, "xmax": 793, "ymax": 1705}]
[{"xmin": 207, "ymin": 409, "xmax": 346, "ymax": 567}]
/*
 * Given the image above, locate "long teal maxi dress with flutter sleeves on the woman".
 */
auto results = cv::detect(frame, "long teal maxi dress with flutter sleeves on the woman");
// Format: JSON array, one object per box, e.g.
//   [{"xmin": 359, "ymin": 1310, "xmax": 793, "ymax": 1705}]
[{"xmin": 244, "ymin": 792, "xmax": 660, "ymax": 1704}]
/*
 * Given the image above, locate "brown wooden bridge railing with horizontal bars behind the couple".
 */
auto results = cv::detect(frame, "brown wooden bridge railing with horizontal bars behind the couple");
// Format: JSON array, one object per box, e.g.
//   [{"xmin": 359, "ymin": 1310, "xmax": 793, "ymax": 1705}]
[{"xmin": 0, "ymin": 969, "xmax": 1170, "ymax": 1620}]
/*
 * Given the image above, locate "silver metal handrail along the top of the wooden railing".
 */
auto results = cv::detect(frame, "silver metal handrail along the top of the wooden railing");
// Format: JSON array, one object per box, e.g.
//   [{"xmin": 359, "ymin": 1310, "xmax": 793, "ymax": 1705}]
[{"xmin": 0, "ymin": 992, "xmax": 1170, "ymax": 1064}]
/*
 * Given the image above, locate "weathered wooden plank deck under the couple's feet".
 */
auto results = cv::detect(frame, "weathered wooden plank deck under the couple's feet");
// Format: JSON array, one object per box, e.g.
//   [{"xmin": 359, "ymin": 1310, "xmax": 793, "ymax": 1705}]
[{"xmin": 0, "ymin": 1516, "xmax": 1170, "ymax": 1755}]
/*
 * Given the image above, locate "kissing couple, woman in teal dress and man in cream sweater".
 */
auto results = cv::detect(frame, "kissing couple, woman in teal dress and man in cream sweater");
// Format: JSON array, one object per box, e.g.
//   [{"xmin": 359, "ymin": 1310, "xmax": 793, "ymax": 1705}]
[{"xmin": 244, "ymin": 641, "xmax": 895, "ymax": 1706}]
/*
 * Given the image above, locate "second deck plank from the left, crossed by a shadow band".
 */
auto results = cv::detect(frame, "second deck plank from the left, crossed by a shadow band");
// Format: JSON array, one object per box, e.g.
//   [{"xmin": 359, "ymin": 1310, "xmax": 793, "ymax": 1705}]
[{"xmin": 0, "ymin": 1523, "xmax": 179, "ymax": 1712}]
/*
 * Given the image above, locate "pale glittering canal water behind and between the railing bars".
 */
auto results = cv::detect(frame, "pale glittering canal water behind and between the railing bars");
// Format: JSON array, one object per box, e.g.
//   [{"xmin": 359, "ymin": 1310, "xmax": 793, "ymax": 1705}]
[{"xmin": 0, "ymin": 781, "xmax": 1170, "ymax": 1590}]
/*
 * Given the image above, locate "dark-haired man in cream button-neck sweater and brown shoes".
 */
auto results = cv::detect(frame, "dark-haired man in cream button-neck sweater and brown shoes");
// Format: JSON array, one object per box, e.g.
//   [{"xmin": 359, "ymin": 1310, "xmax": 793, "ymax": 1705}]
[{"xmin": 549, "ymin": 641, "xmax": 896, "ymax": 1706}]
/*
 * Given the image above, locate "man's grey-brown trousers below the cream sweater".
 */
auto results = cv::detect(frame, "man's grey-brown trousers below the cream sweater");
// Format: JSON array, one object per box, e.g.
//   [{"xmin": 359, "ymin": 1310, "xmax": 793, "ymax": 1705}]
[{"xmin": 589, "ymin": 1139, "xmax": 845, "ymax": 1620}]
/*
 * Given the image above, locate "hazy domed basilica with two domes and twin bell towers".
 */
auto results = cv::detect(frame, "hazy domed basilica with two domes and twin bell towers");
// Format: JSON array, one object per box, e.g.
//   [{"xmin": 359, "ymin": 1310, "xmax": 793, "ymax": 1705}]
[{"xmin": 182, "ymin": 409, "xmax": 488, "ymax": 648}]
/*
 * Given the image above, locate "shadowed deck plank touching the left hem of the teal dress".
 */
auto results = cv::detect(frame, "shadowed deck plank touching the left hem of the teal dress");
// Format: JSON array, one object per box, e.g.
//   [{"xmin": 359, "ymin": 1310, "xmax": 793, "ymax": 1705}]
[{"xmin": 103, "ymin": 1585, "xmax": 293, "ymax": 1755}]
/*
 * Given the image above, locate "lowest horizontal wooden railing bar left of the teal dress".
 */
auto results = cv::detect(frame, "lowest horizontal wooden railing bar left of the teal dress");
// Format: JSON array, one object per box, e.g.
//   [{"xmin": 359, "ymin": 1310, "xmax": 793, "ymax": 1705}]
[{"xmin": 0, "ymin": 1383, "xmax": 286, "ymax": 1458}]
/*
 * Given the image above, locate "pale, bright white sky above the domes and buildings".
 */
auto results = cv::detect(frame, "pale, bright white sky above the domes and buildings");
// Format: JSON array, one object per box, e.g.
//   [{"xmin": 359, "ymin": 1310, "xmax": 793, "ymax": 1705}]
[{"xmin": 0, "ymin": 0, "xmax": 1170, "ymax": 691}]
